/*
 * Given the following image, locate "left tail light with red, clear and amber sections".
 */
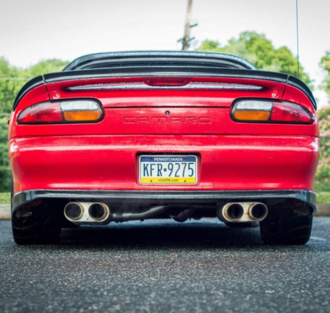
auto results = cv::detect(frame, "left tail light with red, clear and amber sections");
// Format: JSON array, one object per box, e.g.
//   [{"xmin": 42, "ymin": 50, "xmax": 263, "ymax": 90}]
[{"xmin": 18, "ymin": 100, "xmax": 103, "ymax": 124}]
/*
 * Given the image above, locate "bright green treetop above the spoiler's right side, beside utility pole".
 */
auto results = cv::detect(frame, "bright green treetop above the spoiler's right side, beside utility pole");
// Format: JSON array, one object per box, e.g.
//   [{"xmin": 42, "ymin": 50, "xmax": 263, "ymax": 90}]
[{"xmin": 196, "ymin": 32, "xmax": 313, "ymax": 89}]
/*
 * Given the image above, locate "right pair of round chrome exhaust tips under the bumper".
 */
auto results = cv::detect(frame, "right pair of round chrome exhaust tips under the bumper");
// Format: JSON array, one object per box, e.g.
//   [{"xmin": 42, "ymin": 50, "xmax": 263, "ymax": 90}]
[{"xmin": 217, "ymin": 202, "xmax": 268, "ymax": 222}]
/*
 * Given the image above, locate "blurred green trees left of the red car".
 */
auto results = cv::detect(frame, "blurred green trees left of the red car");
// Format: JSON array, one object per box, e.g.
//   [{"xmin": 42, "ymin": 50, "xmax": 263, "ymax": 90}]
[{"xmin": 0, "ymin": 58, "xmax": 68, "ymax": 192}]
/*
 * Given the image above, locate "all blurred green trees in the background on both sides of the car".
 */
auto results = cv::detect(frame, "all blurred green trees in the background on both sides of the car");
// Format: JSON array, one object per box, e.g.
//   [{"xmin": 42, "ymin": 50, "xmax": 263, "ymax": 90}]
[{"xmin": 0, "ymin": 32, "xmax": 330, "ymax": 191}]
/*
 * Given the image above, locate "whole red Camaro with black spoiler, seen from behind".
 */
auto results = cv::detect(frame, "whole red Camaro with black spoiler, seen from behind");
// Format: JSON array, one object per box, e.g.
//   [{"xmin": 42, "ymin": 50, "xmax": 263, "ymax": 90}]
[{"xmin": 9, "ymin": 51, "xmax": 319, "ymax": 244}]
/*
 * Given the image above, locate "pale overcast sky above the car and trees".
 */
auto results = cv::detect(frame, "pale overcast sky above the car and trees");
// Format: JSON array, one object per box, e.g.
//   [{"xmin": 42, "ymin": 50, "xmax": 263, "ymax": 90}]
[{"xmin": 0, "ymin": 0, "xmax": 330, "ymax": 107}]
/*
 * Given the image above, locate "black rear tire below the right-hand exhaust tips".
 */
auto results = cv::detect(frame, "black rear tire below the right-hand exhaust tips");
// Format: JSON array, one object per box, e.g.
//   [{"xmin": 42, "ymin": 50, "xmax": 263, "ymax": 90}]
[{"xmin": 260, "ymin": 207, "xmax": 313, "ymax": 245}]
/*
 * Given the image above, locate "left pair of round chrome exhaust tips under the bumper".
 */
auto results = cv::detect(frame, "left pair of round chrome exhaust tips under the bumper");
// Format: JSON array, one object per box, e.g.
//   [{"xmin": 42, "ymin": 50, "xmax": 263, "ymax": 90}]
[{"xmin": 64, "ymin": 202, "xmax": 110, "ymax": 223}]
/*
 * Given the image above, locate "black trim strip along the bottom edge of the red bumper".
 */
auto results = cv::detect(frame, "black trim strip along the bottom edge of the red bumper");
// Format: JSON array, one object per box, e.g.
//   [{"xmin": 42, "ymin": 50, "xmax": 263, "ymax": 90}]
[{"xmin": 12, "ymin": 190, "xmax": 316, "ymax": 212}]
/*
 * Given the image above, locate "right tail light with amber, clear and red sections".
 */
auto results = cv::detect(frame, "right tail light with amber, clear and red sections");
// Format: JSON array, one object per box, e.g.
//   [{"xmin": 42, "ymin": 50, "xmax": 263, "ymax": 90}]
[{"xmin": 232, "ymin": 100, "xmax": 314, "ymax": 124}]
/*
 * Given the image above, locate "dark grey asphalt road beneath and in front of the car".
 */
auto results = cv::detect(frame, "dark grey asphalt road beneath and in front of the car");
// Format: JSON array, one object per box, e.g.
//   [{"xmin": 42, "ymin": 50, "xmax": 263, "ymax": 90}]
[{"xmin": 0, "ymin": 218, "xmax": 330, "ymax": 313}]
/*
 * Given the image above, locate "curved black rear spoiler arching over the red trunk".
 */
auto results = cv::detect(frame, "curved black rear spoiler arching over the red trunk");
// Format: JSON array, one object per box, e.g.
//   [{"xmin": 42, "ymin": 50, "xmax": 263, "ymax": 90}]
[{"xmin": 13, "ymin": 60, "xmax": 317, "ymax": 110}]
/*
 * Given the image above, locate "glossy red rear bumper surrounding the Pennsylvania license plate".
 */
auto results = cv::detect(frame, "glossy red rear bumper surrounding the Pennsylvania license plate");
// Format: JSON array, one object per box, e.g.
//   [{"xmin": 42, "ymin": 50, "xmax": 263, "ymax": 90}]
[{"xmin": 9, "ymin": 135, "xmax": 319, "ymax": 194}]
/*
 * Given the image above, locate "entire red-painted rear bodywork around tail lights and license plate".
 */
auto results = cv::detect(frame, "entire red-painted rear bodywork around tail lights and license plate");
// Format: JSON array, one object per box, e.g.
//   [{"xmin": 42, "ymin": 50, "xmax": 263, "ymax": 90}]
[{"xmin": 9, "ymin": 78, "xmax": 319, "ymax": 193}]
